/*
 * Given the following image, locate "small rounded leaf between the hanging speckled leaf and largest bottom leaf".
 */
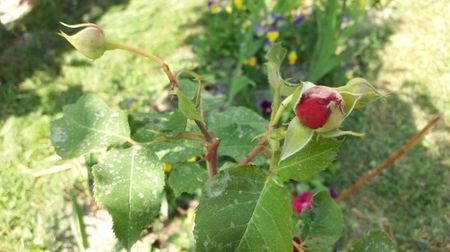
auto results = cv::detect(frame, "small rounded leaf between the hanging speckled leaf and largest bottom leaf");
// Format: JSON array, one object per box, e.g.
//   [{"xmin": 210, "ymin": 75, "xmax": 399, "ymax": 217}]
[{"xmin": 168, "ymin": 164, "xmax": 208, "ymax": 197}]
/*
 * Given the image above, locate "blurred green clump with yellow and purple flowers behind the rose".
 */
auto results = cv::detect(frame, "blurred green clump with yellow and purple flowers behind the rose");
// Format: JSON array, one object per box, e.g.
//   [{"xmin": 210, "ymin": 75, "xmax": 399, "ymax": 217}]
[{"xmin": 191, "ymin": 0, "xmax": 384, "ymax": 103}]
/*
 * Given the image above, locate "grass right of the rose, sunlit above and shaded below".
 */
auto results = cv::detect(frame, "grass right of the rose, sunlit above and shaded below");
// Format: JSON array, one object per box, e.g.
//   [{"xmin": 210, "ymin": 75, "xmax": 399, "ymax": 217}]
[{"xmin": 335, "ymin": 1, "xmax": 450, "ymax": 251}]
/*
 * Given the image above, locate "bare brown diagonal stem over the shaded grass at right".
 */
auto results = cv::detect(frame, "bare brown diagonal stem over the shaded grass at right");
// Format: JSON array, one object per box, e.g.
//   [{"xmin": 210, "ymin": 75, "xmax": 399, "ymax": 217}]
[{"xmin": 336, "ymin": 114, "xmax": 442, "ymax": 202}]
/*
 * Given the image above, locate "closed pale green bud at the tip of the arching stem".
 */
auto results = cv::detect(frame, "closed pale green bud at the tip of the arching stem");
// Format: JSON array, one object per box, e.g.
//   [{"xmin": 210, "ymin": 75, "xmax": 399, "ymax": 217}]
[{"xmin": 59, "ymin": 23, "xmax": 107, "ymax": 60}]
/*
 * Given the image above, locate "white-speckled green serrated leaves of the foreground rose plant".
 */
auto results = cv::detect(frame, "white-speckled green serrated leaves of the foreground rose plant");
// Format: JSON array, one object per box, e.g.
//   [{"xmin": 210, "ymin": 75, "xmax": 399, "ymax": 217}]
[{"xmin": 51, "ymin": 36, "xmax": 394, "ymax": 251}]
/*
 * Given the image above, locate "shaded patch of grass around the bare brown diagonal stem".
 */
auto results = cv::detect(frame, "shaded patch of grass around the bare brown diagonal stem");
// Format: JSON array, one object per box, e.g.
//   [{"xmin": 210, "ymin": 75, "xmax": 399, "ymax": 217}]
[{"xmin": 334, "ymin": 90, "xmax": 450, "ymax": 251}]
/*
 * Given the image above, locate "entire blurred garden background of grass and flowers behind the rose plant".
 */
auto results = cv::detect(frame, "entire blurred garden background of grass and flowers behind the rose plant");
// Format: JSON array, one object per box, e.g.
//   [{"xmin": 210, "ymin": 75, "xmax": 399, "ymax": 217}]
[{"xmin": 0, "ymin": 0, "xmax": 450, "ymax": 251}]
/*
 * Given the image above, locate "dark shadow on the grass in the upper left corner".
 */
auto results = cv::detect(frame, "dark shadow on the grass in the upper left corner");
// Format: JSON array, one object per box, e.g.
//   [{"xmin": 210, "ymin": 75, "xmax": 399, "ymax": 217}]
[{"xmin": 0, "ymin": 0, "xmax": 129, "ymax": 121}]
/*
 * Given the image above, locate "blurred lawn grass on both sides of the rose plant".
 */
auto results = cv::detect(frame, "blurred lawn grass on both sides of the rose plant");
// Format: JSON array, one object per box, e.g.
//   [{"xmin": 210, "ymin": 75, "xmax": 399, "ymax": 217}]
[{"xmin": 0, "ymin": 0, "xmax": 450, "ymax": 251}]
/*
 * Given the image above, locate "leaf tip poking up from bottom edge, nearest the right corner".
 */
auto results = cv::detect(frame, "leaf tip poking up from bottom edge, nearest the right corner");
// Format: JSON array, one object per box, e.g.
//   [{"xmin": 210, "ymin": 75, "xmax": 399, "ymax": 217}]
[{"xmin": 349, "ymin": 230, "xmax": 397, "ymax": 252}]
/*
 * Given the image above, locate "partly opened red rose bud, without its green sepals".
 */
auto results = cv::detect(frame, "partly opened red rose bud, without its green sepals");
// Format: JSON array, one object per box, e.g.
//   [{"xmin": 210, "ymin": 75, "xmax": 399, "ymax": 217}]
[{"xmin": 295, "ymin": 86, "xmax": 345, "ymax": 132}]
